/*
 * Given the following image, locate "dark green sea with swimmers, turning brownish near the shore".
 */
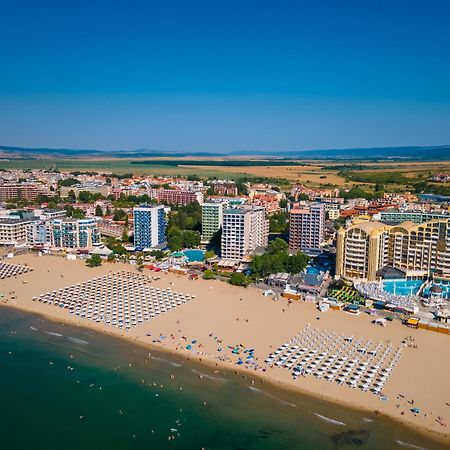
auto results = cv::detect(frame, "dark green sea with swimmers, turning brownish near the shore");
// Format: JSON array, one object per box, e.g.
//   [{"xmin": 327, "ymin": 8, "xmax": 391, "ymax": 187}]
[{"xmin": 0, "ymin": 308, "xmax": 445, "ymax": 450}]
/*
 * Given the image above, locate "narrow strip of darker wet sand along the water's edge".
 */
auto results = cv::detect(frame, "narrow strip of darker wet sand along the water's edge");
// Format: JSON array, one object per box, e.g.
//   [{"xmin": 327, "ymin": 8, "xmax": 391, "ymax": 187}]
[{"xmin": 0, "ymin": 303, "xmax": 450, "ymax": 444}]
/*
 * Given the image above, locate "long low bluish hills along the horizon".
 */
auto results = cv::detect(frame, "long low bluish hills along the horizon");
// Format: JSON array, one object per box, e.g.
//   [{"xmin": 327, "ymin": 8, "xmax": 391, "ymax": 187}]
[{"xmin": 0, "ymin": 145, "xmax": 450, "ymax": 161}]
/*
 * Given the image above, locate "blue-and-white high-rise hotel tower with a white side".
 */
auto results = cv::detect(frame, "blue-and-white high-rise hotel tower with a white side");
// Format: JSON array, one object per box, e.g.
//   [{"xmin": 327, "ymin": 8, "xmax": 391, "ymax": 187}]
[{"xmin": 133, "ymin": 205, "xmax": 166, "ymax": 249}]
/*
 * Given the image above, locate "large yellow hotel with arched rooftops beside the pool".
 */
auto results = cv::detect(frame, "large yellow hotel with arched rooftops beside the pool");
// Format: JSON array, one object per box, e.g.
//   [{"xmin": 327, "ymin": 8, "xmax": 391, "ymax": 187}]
[{"xmin": 336, "ymin": 219, "xmax": 450, "ymax": 281}]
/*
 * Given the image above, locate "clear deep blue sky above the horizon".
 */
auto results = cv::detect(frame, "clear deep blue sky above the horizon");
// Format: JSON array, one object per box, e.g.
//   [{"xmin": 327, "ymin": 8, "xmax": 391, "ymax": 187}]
[{"xmin": 0, "ymin": 0, "xmax": 450, "ymax": 153}]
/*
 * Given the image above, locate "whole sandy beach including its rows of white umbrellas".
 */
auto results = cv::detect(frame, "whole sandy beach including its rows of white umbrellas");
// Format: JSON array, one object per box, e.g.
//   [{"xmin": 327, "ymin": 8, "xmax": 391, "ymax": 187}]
[{"xmin": 0, "ymin": 255, "xmax": 450, "ymax": 442}]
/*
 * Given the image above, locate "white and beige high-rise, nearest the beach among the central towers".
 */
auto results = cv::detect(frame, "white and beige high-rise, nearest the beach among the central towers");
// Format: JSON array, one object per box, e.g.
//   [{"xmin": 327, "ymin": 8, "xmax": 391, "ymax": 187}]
[{"xmin": 221, "ymin": 206, "xmax": 269, "ymax": 260}]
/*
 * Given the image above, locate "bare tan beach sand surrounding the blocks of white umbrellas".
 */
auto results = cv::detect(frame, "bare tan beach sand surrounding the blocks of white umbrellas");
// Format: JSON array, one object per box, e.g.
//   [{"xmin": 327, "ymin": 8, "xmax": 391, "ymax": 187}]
[{"xmin": 0, "ymin": 255, "xmax": 450, "ymax": 442}]
